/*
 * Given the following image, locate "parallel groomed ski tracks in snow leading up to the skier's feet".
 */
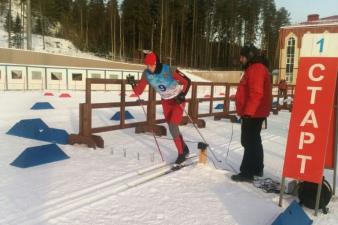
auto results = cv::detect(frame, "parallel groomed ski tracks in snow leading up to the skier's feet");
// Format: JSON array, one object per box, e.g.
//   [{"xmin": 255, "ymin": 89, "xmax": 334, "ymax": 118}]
[{"xmin": 0, "ymin": 154, "xmax": 197, "ymax": 225}]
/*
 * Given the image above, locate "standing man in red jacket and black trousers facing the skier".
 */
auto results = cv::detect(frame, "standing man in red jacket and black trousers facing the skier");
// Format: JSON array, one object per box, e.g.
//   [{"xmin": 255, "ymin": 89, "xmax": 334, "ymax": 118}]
[{"xmin": 231, "ymin": 45, "xmax": 271, "ymax": 182}]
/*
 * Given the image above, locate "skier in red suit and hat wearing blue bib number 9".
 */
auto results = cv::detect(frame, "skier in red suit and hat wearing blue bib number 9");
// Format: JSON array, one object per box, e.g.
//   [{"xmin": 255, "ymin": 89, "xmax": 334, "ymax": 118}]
[{"xmin": 127, "ymin": 52, "xmax": 191, "ymax": 164}]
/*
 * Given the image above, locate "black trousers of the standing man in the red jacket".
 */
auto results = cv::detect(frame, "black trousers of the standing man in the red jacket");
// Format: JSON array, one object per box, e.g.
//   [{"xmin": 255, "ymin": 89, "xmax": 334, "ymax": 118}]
[{"xmin": 240, "ymin": 118, "xmax": 265, "ymax": 176}]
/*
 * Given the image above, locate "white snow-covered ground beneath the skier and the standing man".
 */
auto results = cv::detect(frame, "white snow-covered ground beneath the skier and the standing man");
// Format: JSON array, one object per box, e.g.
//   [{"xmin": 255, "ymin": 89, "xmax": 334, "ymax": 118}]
[{"xmin": 0, "ymin": 92, "xmax": 338, "ymax": 225}]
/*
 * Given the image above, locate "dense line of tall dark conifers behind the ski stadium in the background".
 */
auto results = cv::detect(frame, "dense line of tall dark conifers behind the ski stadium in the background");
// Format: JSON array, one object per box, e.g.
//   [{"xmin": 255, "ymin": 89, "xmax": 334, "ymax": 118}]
[{"xmin": 0, "ymin": 0, "xmax": 290, "ymax": 69}]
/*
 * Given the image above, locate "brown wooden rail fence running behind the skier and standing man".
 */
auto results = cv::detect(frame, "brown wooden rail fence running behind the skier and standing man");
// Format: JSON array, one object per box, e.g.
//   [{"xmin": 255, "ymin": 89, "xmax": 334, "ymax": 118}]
[{"xmin": 69, "ymin": 78, "xmax": 294, "ymax": 148}]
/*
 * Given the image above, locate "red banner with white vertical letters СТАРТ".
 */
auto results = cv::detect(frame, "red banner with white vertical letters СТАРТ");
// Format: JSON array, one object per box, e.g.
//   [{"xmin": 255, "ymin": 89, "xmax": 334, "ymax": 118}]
[{"xmin": 283, "ymin": 57, "xmax": 338, "ymax": 183}]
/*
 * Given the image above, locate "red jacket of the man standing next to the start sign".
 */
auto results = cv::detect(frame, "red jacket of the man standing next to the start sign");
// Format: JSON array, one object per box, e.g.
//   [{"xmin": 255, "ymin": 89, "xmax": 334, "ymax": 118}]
[{"xmin": 236, "ymin": 63, "xmax": 272, "ymax": 118}]
